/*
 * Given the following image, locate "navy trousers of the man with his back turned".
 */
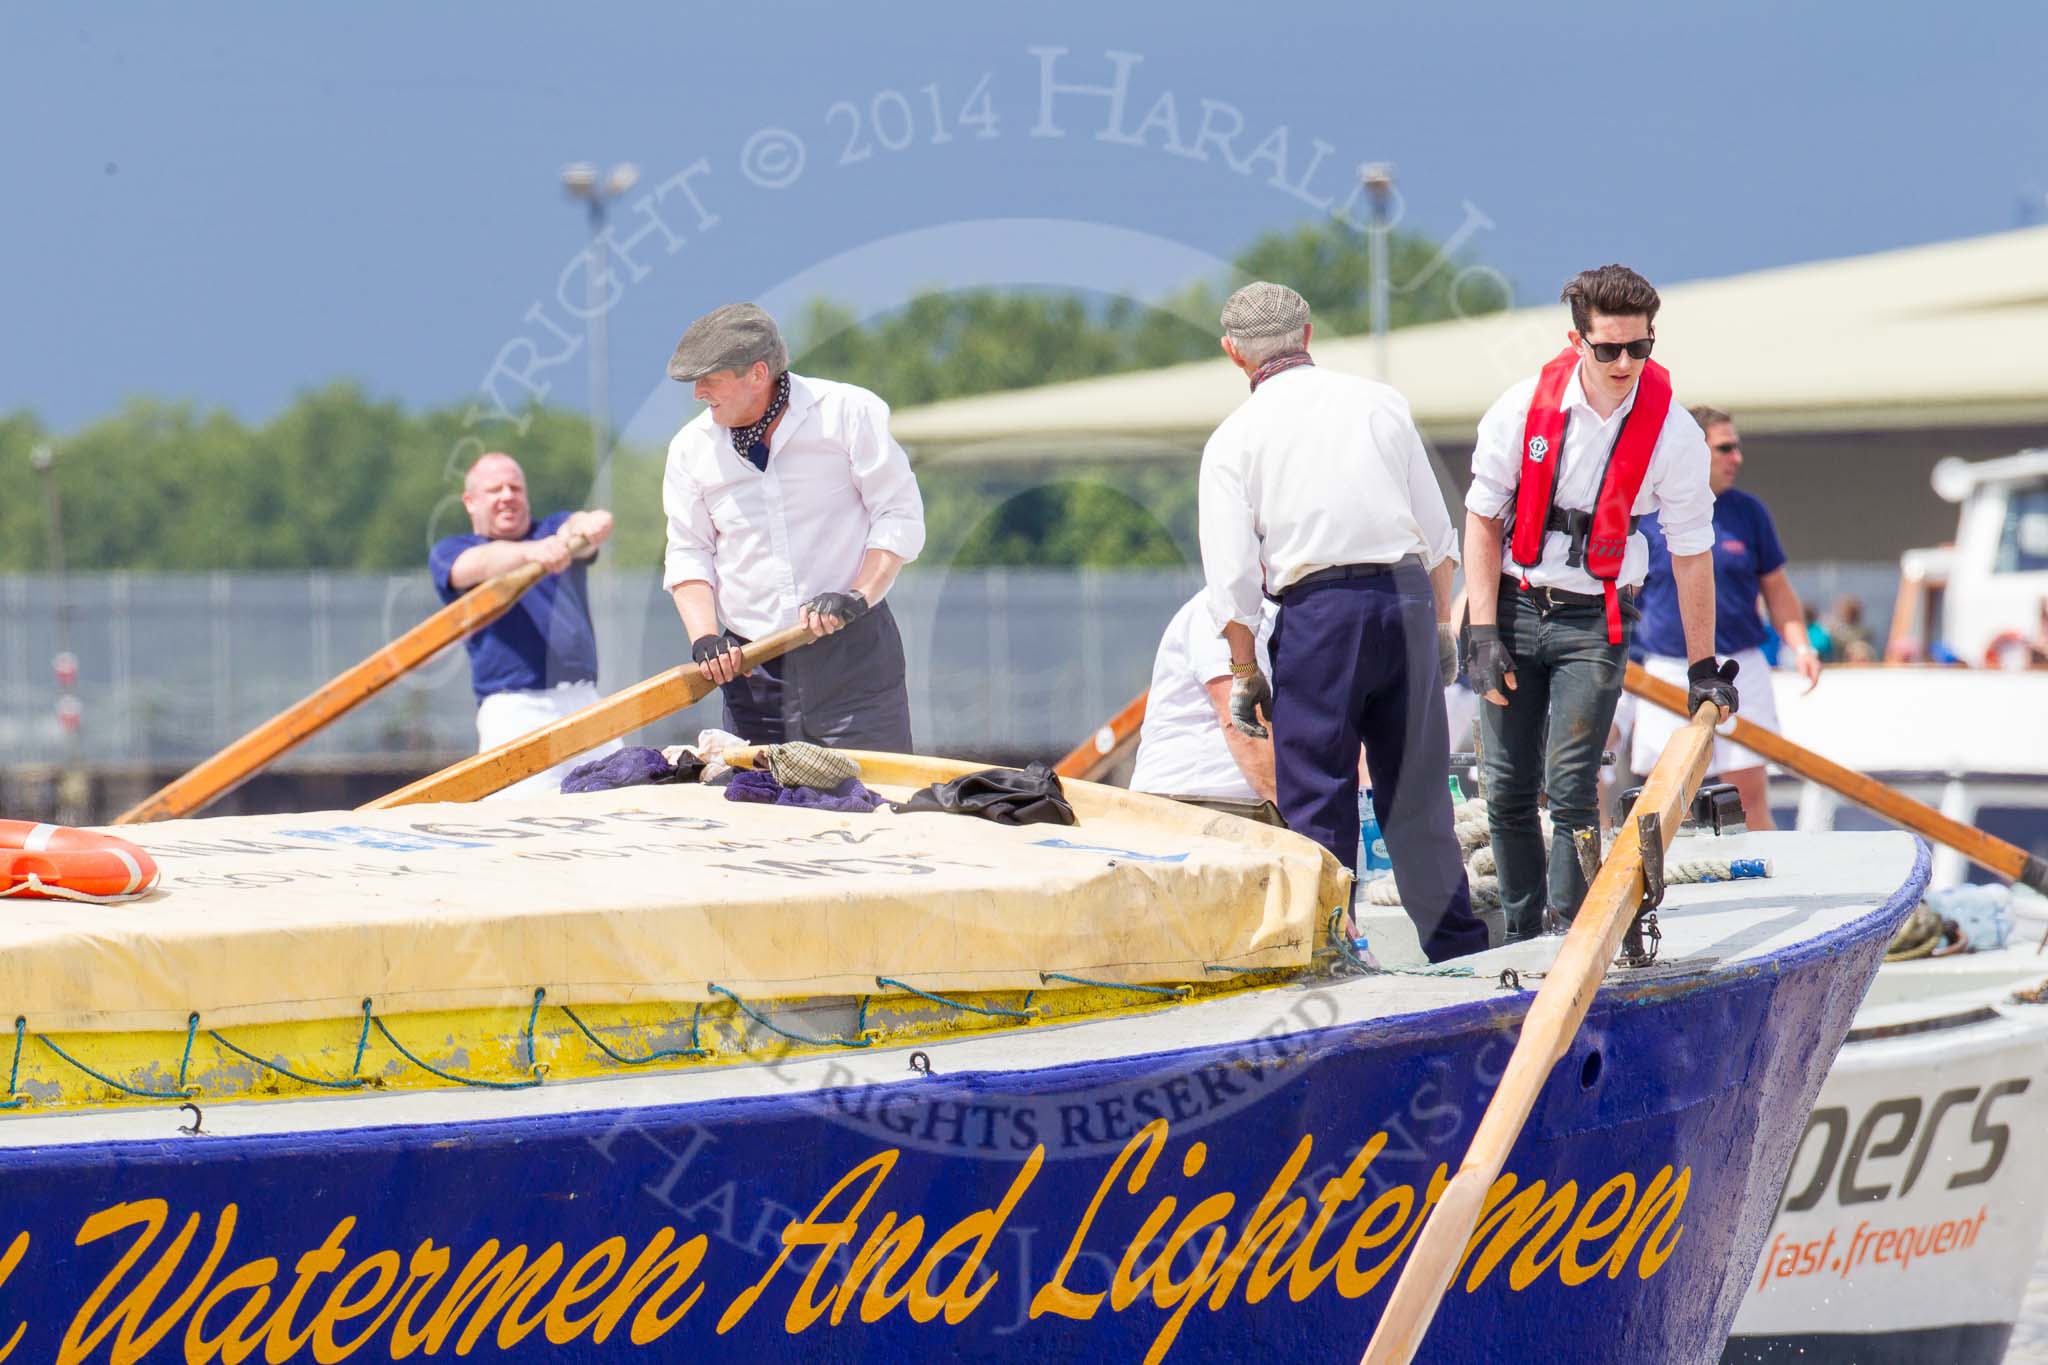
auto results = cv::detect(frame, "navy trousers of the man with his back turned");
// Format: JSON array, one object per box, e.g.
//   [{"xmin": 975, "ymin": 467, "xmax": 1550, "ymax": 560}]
[{"xmin": 1272, "ymin": 565, "xmax": 1487, "ymax": 962}]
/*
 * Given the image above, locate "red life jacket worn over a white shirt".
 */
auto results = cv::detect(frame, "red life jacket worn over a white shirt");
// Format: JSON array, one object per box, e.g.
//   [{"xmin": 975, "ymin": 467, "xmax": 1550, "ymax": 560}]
[{"xmin": 1509, "ymin": 346, "xmax": 1671, "ymax": 645}]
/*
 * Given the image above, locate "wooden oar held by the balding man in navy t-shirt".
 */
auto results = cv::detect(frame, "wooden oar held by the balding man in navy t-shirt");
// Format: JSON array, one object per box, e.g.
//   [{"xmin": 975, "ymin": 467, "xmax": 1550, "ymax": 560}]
[{"xmin": 115, "ymin": 536, "xmax": 588, "ymax": 825}]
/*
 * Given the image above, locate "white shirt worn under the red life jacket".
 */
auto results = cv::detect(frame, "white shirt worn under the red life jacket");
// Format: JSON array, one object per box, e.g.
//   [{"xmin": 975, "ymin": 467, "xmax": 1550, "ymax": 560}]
[{"xmin": 1464, "ymin": 368, "xmax": 1714, "ymax": 593}]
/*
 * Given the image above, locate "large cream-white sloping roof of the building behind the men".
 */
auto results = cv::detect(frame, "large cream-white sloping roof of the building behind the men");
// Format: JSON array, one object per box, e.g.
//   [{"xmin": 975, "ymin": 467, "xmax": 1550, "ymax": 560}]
[{"xmin": 893, "ymin": 227, "xmax": 2048, "ymax": 456}]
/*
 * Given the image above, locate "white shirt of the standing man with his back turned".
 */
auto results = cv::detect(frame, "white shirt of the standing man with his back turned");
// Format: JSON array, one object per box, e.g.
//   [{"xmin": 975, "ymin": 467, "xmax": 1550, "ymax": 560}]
[{"xmin": 1198, "ymin": 364, "xmax": 1458, "ymax": 630}]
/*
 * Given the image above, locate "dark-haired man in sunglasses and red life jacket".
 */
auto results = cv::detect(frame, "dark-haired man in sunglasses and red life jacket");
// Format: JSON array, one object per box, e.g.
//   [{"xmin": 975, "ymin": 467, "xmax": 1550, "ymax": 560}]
[{"xmin": 1464, "ymin": 266, "xmax": 1737, "ymax": 941}]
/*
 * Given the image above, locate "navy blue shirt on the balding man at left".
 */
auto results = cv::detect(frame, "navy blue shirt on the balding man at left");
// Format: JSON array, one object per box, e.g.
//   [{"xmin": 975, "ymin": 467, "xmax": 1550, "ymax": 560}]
[{"xmin": 426, "ymin": 512, "xmax": 598, "ymax": 700}]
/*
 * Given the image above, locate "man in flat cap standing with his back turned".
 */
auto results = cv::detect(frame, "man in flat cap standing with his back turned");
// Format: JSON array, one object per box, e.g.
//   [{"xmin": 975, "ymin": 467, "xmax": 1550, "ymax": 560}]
[{"xmin": 1200, "ymin": 282, "xmax": 1487, "ymax": 962}]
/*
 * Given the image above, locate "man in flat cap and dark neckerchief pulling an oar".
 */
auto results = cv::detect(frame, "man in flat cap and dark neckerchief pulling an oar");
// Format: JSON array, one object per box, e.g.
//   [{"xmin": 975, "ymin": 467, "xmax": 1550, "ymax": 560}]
[{"xmin": 662, "ymin": 303, "xmax": 924, "ymax": 753}]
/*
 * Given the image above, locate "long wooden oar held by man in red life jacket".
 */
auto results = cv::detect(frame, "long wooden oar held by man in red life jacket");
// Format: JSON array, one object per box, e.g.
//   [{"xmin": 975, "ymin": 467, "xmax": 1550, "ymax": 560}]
[{"xmin": 1364, "ymin": 706, "xmax": 1716, "ymax": 1365}]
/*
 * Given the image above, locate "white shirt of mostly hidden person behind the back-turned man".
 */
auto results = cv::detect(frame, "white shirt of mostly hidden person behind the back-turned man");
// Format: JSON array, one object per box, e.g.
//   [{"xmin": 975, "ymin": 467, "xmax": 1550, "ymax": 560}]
[{"xmin": 1130, "ymin": 593, "xmax": 1276, "ymax": 800}]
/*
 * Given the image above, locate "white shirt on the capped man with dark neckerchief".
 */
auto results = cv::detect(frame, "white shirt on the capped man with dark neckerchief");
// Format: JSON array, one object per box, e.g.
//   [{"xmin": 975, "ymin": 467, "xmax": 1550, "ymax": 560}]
[{"xmin": 662, "ymin": 375, "xmax": 924, "ymax": 641}]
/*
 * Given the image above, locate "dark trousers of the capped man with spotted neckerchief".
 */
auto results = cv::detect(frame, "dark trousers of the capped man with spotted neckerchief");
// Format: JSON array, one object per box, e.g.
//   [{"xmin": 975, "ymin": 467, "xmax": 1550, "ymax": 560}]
[{"xmin": 721, "ymin": 602, "xmax": 911, "ymax": 753}]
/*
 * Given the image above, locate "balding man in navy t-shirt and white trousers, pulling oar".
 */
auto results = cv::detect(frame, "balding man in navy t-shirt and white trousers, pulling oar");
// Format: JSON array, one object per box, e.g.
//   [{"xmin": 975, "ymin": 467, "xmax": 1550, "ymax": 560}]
[{"xmin": 428, "ymin": 452, "xmax": 618, "ymax": 796}]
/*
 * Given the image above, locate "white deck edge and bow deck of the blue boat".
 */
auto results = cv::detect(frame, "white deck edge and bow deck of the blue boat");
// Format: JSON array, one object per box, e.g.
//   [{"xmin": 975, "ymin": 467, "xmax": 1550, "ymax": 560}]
[{"xmin": 0, "ymin": 833, "xmax": 1915, "ymax": 1148}]
